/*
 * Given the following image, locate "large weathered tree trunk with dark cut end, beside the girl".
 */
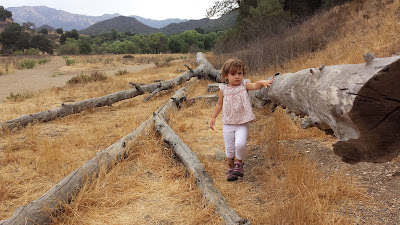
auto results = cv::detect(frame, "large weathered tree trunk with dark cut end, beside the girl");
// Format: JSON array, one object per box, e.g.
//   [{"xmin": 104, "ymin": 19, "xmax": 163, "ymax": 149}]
[{"xmin": 197, "ymin": 54, "xmax": 400, "ymax": 163}]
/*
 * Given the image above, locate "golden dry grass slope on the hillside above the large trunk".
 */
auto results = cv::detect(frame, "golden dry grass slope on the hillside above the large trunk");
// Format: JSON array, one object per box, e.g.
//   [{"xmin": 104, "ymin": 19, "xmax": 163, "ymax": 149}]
[{"xmin": 271, "ymin": 0, "xmax": 400, "ymax": 72}]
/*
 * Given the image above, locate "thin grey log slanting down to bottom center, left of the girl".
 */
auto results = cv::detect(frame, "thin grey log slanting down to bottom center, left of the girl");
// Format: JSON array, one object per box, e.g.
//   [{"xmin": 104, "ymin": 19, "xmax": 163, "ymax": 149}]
[{"xmin": 154, "ymin": 93, "xmax": 250, "ymax": 224}]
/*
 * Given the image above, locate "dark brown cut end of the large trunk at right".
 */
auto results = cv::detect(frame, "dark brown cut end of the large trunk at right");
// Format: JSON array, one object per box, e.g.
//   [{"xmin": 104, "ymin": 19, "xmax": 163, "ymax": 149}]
[{"xmin": 333, "ymin": 55, "xmax": 400, "ymax": 163}]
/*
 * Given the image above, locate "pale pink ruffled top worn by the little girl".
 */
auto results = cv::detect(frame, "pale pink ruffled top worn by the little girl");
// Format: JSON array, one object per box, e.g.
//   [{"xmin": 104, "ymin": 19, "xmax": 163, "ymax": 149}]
[{"xmin": 219, "ymin": 79, "xmax": 256, "ymax": 124}]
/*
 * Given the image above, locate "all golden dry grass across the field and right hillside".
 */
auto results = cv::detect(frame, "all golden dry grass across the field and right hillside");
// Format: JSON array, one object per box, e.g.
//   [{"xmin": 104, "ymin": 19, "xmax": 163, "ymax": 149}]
[{"xmin": 0, "ymin": 0, "xmax": 400, "ymax": 224}]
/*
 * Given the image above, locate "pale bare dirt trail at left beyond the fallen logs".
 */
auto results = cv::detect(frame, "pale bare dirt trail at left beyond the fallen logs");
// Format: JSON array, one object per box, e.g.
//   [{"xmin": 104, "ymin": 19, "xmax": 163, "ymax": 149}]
[{"xmin": 0, "ymin": 56, "xmax": 154, "ymax": 102}]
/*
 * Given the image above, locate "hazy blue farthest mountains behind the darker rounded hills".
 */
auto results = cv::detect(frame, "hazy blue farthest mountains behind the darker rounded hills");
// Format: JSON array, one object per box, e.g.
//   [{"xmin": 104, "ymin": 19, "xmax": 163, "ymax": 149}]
[{"xmin": 6, "ymin": 6, "xmax": 187, "ymax": 31}]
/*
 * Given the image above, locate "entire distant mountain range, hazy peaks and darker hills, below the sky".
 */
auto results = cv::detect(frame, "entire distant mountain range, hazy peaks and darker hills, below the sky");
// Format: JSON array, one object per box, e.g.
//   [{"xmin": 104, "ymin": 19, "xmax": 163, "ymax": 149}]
[{"xmin": 7, "ymin": 6, "xmax": 238, "ymax": 35}]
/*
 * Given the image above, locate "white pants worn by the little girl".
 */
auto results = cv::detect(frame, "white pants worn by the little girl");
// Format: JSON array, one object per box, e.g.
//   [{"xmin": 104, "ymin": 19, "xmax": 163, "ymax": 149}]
[{"xmin": 223, "ymin": 123, "xmax": 249, "ymax": 160}]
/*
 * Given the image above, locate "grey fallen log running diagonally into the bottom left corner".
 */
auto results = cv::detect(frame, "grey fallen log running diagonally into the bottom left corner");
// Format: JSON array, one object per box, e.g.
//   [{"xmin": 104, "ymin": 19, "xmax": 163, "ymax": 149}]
[{"xmin": 0, "ymin": 117, "xmax": 153, "ymax": 225}]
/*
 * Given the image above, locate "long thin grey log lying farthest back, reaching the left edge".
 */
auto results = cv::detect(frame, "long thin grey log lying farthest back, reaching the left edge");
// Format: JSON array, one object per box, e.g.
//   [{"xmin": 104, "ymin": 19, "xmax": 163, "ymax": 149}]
[{"xmin": 0, "ymin": 70, "xmax": 195, "ymax": 132}]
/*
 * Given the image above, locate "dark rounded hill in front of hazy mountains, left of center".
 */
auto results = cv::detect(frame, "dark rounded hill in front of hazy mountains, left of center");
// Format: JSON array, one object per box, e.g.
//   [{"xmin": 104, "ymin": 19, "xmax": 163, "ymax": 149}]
[{"xmin": 79, "ymin": 16, "xmax": 158, "ymax": 34}]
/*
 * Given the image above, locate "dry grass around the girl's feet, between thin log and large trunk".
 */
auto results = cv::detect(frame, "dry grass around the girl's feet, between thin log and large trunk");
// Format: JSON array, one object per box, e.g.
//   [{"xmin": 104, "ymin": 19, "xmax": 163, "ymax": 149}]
[{"xmin": 170, "ymin": 102, "xmax": 366, "ymax": 224}]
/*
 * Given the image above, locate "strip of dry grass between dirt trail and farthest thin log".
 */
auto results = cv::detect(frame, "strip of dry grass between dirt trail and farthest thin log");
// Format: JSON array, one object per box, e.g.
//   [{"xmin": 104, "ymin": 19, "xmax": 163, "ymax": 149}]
[{"xmin": 0, "ymin": 55, "xmax": 195, "ymax": 121}]
